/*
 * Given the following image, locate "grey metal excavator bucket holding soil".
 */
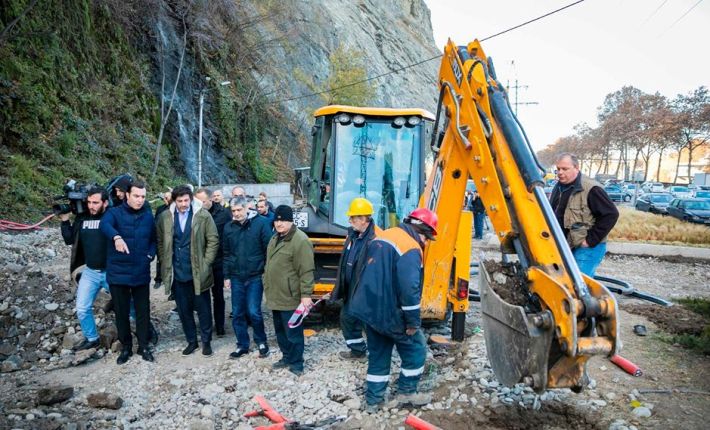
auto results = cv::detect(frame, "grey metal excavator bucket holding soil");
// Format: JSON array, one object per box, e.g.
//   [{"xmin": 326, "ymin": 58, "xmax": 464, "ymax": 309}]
[{"xmin": 478, "ymin": 264, "xmax": 554, "ymax": 392}]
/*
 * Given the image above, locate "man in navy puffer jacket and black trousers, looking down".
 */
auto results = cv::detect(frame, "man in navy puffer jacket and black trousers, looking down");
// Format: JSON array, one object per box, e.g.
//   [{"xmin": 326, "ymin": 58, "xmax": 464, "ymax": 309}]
[{"xmin": 100, "ymin": 180, "xmax": 156, "ymax": 364}]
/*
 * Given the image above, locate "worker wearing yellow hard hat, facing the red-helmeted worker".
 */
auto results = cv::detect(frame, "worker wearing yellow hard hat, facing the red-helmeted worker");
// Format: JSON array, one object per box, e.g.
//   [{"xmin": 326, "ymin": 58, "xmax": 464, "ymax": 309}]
[{"xmin": 331, "ymin": 197, "xmax": 382, "ymax": 361}]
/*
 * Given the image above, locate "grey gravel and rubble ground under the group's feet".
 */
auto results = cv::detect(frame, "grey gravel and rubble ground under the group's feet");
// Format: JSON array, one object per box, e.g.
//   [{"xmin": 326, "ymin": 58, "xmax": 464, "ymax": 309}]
[{"xmin": 0, "ymin": 229, "xmax": 709, "ymax": 430}]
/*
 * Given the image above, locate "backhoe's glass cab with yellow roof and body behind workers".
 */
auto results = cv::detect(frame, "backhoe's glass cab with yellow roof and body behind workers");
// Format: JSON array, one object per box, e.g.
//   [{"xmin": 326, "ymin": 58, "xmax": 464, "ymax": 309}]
[{"xmin": 294, "ymin": 105, "xmax": 471, "ymax": 340}]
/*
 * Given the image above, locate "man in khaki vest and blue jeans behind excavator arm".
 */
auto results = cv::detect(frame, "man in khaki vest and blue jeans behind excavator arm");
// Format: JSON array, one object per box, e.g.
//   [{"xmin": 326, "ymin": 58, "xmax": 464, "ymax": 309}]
[{"xmin": 550, "ymin": 152, "xmax": 619, "ymax": 276}]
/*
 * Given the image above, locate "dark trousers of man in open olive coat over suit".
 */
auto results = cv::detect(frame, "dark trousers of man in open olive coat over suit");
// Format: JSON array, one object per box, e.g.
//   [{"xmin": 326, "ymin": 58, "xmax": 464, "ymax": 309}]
[{"xmin": 173, "ymin": 281, "xmax": 212, "ymax": 343}]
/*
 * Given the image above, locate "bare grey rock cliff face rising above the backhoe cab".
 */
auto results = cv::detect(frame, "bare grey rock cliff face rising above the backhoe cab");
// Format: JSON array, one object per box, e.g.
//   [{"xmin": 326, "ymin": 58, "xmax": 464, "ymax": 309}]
[{"xmin": 248, "ymin": 0, "xmax": 440, "ymax": 123}]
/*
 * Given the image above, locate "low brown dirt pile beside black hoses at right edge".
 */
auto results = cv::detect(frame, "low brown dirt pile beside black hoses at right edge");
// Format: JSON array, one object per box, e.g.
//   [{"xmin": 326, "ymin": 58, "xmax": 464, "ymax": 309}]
[{"xmin": 622, "ymin": 304, "xmax": 710, "ymax": 336}]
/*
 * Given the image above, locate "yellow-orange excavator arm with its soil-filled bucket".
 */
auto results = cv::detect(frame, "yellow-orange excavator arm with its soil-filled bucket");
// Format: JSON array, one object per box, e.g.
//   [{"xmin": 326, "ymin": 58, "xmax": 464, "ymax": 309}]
[{"xmin": 422, "ymin": 40, "xmax": 620, "ymax": 391}]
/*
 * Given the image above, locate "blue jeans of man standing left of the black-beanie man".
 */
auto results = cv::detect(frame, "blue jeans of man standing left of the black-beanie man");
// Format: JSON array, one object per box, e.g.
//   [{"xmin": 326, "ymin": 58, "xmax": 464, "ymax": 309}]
[{"xmin": 230, "ymin": 276, "xmax": 268, "ymax": 349}]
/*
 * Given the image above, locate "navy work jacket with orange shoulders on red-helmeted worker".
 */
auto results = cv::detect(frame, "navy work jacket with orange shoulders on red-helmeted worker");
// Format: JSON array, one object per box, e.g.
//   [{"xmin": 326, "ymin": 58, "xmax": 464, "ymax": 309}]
[{"xmin": 350, "ymin": 224, "xmax": 422, "ymax": 336}]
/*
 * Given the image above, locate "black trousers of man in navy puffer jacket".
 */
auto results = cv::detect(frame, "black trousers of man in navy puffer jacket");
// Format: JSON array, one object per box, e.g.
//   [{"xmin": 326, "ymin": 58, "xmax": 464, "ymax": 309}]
[{"xmin": 109, "ymin": 284, "xmax": 150, "ymax": 349}]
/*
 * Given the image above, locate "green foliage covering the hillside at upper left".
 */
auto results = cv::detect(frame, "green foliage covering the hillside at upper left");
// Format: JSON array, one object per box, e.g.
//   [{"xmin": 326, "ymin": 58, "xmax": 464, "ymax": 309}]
[{"xmin": 0, "ymin": 0, "xmax": 177, "ymax": 219}]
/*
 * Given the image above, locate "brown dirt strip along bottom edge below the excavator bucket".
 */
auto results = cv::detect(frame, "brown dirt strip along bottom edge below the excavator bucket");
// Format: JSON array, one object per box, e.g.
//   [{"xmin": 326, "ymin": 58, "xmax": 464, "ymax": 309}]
[{"xmin": 421, "ymin": 402, "xmax": 605, "ymax": 430}]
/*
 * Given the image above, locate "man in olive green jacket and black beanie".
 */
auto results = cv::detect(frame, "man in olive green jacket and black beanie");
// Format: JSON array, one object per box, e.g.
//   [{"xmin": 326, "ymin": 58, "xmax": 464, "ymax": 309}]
[{"xmin": 264, "ymin": 205, "xmax": 315, "ymax": 376}]
